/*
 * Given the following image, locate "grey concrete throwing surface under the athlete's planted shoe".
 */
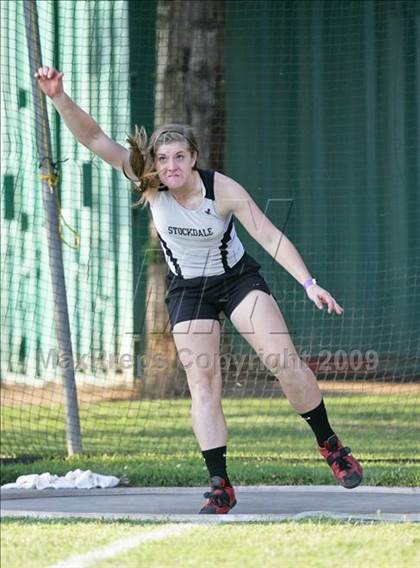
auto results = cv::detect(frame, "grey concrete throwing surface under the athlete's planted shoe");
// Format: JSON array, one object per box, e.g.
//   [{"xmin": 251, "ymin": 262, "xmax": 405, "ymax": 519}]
[{"xmin": 1, "ymin": 486, "xmax": 420, "ymax": 523}]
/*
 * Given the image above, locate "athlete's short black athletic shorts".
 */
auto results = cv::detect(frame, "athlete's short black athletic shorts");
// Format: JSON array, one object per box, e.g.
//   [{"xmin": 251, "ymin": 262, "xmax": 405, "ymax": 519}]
[{"xmin": 165, "ymin": 253, "xmax": 271, "ymax": 327}]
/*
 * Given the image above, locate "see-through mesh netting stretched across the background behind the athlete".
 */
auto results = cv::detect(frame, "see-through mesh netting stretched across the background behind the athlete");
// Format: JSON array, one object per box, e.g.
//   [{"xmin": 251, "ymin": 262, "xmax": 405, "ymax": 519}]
[{"xmin": 0, "ymin": 0, "xmax": 420, "ymax": 458}]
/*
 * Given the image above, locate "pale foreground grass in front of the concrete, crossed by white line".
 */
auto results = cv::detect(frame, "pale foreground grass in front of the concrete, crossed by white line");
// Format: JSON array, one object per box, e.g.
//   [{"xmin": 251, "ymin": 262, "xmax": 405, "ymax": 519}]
[{"xmin": 2, "ymin": 519, "xmax": 420, "ymax": 568}]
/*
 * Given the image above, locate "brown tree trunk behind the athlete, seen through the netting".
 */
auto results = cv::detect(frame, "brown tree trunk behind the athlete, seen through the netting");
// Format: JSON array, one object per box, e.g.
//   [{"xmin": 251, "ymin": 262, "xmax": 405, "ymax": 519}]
[{"xmin": 142, "ymin": 0, "xmax": 224, "ymax": 398}]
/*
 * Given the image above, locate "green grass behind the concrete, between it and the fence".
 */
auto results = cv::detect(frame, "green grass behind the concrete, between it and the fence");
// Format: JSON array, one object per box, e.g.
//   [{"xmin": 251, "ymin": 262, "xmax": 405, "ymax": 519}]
[{"xmin": 1, "ymin": 392, "xmax": 420, "ymax": 486}]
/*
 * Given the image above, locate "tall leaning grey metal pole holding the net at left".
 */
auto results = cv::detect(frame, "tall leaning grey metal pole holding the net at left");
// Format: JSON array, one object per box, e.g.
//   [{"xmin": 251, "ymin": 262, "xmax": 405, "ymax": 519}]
[{"xmin": 24, "ymin": 0, "xmax": 82, "ymax": 455}]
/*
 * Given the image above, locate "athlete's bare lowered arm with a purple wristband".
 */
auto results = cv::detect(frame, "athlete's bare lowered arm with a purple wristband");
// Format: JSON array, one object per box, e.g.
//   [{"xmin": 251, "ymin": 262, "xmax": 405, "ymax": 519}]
[{"xmin": 215, "ymin": 174, "xmax": 344, "ymax": 314}]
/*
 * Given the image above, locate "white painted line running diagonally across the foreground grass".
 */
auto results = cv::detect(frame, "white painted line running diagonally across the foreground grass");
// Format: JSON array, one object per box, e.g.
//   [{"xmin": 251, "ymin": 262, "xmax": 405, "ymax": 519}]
[{"xmin": 50, "ymin": 525, "xmax": 193, "ymax": 568}]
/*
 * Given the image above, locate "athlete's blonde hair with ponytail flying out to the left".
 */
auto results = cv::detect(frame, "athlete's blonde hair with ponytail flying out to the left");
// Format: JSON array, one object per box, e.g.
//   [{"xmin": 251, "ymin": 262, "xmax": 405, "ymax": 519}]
[{"xmin": 123, "ymin": 124, "xmax": 199, "ymax": 205}]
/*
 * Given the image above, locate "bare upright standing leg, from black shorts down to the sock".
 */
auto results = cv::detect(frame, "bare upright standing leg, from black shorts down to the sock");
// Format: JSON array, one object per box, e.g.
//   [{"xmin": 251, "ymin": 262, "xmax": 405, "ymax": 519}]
[{"xmin": 173, "ymin": 320, "xmax": 227, "ymax": 451}]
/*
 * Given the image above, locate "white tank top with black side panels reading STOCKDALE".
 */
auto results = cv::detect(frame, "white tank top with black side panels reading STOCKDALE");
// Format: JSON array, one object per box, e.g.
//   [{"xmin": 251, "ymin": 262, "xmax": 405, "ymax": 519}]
[{"xmin": 150, "ymin": 170, "xmax": 245, "ymax": 278}]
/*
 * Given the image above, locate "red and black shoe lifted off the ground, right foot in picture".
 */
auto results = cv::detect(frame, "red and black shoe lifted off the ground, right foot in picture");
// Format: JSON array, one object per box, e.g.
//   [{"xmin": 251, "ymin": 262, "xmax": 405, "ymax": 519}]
[{"xmin": 318, "ymin": 434, "xmax": 363, "ymax": 489}]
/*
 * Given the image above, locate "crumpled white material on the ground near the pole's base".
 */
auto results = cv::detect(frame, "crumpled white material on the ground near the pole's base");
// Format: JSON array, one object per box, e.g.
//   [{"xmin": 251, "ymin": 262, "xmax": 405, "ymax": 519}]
[{"xmin": 1, "ymin": 469, "xmax": 120, "ymax": 489}]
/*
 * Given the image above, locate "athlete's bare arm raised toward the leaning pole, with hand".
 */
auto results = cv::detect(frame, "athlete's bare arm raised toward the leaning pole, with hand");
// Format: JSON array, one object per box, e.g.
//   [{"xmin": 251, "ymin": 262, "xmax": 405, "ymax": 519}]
[{"xmin": 35, "ymin": 66, "xmax": 135, "ymax": 179}]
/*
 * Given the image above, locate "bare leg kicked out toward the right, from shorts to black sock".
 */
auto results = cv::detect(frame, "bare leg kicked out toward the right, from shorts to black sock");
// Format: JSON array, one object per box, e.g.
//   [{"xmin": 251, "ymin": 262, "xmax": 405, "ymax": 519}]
[{"xmin": 230, "ymin": 290, "xmax": 322, "ymax": 414}]
